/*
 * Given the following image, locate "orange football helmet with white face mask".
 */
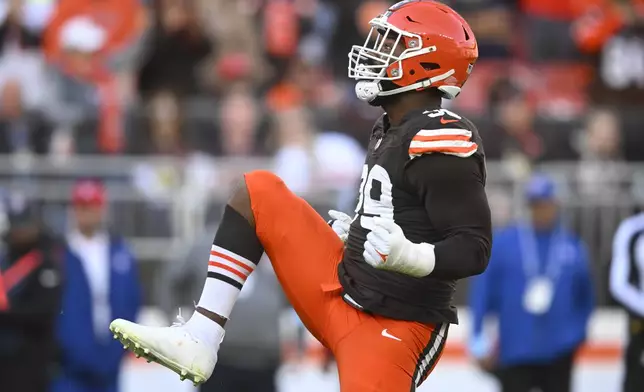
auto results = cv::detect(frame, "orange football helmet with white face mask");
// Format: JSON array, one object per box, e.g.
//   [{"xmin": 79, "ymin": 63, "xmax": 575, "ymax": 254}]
[{"xmin": 349, "ymin": 0, "xmax": 478, "ymax": 104}]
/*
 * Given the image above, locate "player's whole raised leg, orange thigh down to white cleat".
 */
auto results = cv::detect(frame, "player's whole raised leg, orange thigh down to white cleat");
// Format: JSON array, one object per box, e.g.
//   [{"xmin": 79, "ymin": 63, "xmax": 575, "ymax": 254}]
[{"xmin": 110, "ymin": 171, "xmax": 343, "ymax": 384}]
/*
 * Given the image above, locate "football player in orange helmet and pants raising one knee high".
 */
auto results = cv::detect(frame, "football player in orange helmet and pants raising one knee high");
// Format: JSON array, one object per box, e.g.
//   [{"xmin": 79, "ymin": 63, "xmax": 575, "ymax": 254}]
[{"xmin": 111, "ymin": 0, "xmax": 491, "ymax": 392}]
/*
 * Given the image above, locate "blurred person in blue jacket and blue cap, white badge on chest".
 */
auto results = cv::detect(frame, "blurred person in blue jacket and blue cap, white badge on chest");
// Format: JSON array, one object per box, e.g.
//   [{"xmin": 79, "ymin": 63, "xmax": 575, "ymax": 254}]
[{"xmin": 470, "ymin": 174, "xmax": 594, "ymax": 392}]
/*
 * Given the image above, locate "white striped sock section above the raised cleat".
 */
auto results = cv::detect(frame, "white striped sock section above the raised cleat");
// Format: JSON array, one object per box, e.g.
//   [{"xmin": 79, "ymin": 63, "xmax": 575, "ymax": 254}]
[{"xmin": 192, "ymin": 245, "xmax": 257, "ymax": 318}]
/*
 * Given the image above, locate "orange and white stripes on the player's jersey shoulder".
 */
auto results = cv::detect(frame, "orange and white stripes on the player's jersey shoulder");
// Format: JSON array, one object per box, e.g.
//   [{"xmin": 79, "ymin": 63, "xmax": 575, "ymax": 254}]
[{"xmin": 409, "ymin": 128, "xmax": 478, "ymax": 159}]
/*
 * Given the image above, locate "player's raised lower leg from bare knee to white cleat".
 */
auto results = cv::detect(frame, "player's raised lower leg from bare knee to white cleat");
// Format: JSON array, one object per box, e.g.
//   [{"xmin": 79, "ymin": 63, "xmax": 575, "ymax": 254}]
[{"xmin": 110, "ymin": 189, "xmax": 264, "ymax": 384}]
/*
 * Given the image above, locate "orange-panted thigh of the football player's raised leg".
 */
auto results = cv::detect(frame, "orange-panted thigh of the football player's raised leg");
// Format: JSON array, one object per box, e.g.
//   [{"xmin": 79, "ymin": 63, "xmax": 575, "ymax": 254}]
[{"xmin": 246, "ymin": 172, "xmax": 344, "ymax": 345}]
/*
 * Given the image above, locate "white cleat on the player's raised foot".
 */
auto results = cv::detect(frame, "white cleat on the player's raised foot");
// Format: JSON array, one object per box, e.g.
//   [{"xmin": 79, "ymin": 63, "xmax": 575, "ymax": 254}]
[{"xmin": 110, "ymin": 319, "xmax": 223, "ymax": 386}]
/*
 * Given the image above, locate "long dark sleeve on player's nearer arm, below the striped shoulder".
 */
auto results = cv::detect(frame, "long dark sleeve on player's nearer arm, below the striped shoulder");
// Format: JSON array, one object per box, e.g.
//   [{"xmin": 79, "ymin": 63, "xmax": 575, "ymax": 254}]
[{"xmin": 405, "ymin": 154, "xmax": 492, "ymax": 279}]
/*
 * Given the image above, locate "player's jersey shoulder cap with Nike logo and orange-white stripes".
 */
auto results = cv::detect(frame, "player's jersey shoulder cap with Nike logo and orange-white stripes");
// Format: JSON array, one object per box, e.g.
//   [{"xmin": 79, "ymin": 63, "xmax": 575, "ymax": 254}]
[{"xmin": 409, "ymin": 109, "xmax": 478, "ymax": 159}]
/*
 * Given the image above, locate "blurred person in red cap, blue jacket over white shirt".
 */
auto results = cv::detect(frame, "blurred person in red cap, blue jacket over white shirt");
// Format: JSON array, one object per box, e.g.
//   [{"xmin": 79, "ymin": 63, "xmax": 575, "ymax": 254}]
[{"xmin": 52, "ymin": 181, "xmax": 141, "ymax": 392}]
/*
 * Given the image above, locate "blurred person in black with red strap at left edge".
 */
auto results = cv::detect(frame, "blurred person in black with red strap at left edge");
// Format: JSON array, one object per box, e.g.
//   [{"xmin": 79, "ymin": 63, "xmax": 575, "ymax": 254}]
[{"xmin": 0, "ymin": 194, "xmax": 62, "ymax": 392}]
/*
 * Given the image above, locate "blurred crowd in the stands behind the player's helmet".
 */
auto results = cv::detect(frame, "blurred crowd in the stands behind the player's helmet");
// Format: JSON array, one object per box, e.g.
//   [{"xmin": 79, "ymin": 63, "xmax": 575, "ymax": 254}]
[{"xmin": 0, "ymin": 0, "xmax": 644, "ymax": 164}]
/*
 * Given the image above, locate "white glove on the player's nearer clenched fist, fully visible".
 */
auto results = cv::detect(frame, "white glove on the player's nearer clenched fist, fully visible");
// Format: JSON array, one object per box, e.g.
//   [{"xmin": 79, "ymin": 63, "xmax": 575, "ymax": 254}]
[{"xmin": 362, "ymin": 217, "xmax": 436, "ymax": 278}]
